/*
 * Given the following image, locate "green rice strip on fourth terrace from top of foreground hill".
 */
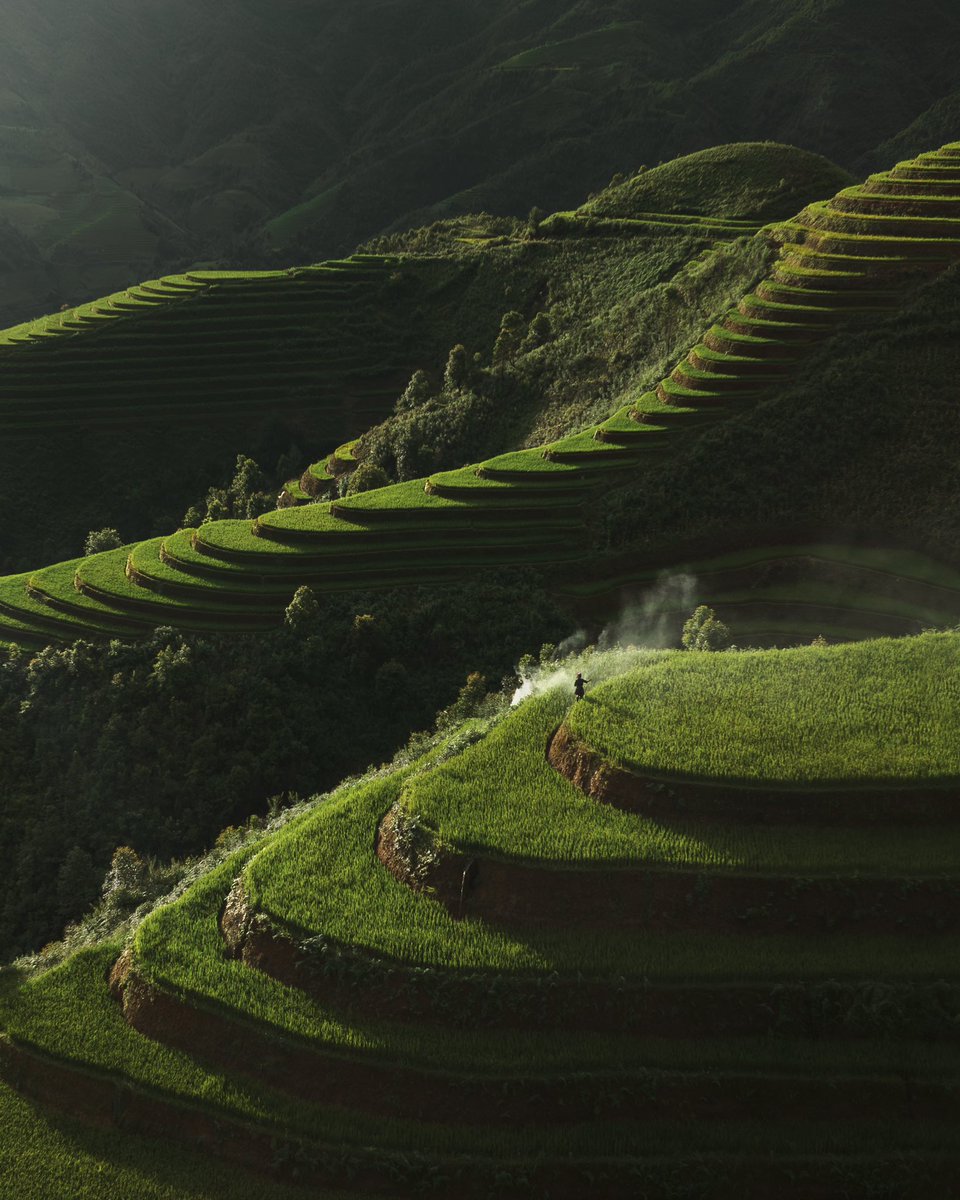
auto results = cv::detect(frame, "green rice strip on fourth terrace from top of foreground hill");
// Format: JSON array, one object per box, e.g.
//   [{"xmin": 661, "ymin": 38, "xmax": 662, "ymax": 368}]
[{"xmin": 129, "ymin": 856, "xmax": 960, "ymax": 1078}]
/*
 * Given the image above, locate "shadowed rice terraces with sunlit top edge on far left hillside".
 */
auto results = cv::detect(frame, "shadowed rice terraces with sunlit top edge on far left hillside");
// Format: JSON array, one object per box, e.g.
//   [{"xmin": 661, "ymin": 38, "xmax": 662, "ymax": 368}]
[{"xmin": 0, "ymin": 256, "xmax": 407, "ymax": 437}]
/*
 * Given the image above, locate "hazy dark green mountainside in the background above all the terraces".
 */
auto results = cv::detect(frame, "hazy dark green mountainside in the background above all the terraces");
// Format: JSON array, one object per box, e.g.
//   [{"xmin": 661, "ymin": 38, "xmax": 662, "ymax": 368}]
[{"xmin": 0, "ymin": 0, "xmax": 960, "ymax": 323}]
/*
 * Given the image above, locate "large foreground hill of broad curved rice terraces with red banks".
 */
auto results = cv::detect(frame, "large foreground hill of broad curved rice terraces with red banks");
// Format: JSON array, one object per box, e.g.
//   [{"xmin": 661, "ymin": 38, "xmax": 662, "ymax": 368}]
[{"xmin": 0, "ymin": 635, "xmax": 960, "ymax": 1200}]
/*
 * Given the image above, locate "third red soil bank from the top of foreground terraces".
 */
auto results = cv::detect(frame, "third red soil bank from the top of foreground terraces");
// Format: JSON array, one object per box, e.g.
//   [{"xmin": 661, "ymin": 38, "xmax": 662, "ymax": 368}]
[{"xmin": 221, "ymin": 883, "xmax": 960, "ymax": 1040}]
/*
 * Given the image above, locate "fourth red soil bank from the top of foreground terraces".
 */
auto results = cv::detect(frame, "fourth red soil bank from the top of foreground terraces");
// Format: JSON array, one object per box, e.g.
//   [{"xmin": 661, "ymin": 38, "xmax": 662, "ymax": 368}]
[{"xmin": 110, "ymin": 955, "xmax": 960, "ymax": 1127}]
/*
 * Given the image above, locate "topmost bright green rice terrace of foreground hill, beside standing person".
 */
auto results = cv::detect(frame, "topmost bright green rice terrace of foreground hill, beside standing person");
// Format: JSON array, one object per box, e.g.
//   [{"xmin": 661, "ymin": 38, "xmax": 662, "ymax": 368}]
[{"xmin": 569, "ymin": 634, "xmax": 960, "ymax": 785}]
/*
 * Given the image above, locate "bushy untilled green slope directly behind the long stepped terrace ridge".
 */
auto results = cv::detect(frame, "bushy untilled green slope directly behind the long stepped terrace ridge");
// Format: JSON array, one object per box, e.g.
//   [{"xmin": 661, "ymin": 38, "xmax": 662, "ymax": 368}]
[{"xmin": 360, "ymin": 224, "xmax": 770, "ymax": 480}]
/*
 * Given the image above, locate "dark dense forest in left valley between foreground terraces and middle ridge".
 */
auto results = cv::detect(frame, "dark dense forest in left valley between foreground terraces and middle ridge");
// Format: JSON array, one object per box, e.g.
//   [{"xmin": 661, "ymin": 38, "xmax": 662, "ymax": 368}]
[{"xmin": 0, "ymin": 578, "xmax": 564, "ymax": 954}]
